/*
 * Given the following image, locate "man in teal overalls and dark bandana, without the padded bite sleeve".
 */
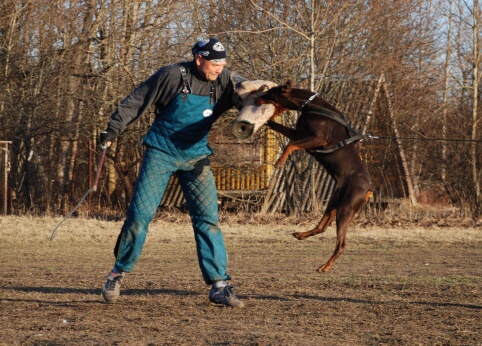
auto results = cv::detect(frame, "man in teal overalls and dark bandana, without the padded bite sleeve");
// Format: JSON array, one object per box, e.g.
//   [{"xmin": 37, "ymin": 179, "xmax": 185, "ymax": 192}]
[{"xmin": 100, "ymin": 38, "xmax": 244, "ymax": 308}]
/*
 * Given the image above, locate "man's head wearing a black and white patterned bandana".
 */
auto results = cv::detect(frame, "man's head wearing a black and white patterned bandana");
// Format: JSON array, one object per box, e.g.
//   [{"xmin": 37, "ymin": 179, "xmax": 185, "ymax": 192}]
[{"xmin": 191, "ymin": 38, "xmax": 226, "ymax": 81}]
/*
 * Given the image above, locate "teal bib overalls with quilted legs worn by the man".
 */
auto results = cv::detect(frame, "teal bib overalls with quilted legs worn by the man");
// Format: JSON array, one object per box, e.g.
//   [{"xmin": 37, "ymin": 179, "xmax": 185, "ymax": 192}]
[{"xmin": 115, "ymin": 94, "xmax": 229, "ymax": 284}]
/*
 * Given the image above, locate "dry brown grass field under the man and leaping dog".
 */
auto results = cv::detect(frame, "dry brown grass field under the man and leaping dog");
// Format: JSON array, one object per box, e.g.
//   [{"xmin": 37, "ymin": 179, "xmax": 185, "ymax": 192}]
[{"xmin": 0, "ymin": 216, "xmax": 482, "ymax": 345}]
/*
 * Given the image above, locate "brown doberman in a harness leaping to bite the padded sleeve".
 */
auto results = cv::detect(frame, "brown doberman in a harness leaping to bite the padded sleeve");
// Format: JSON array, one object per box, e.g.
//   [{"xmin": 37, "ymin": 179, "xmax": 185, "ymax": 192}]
[{"xmin": 233, "ymin": 81, "xmax": 372, "ymax": 272}]
